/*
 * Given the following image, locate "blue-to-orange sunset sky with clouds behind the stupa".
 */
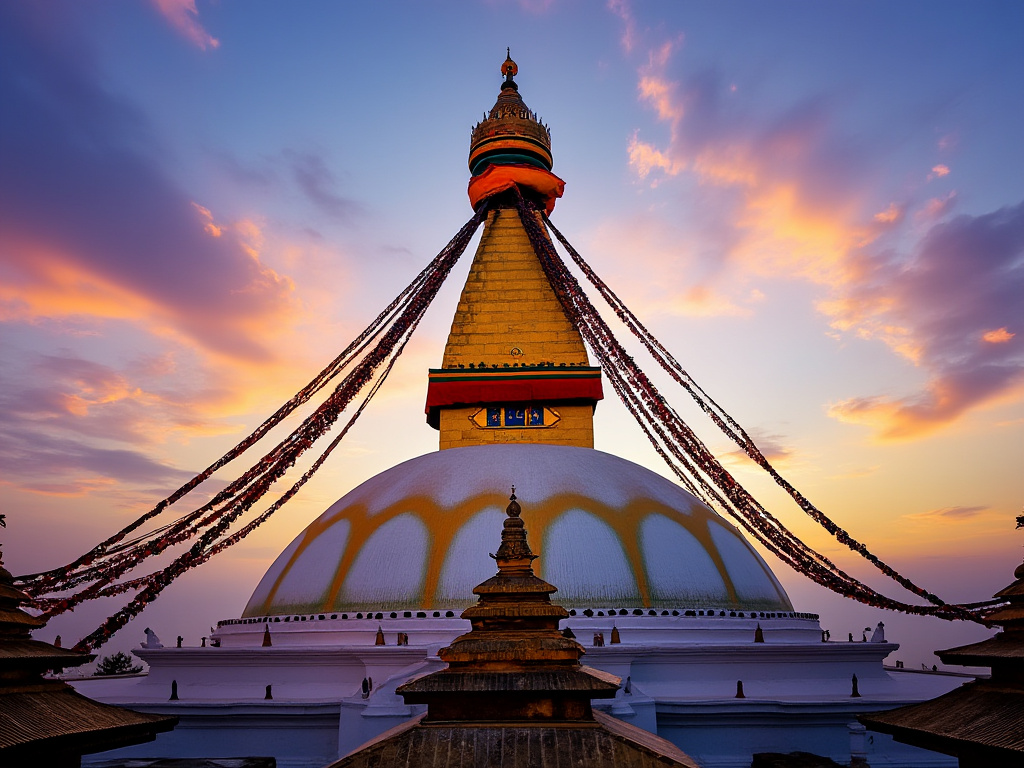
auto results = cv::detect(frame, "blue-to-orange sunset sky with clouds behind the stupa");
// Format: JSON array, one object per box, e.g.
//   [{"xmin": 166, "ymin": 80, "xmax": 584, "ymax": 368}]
[{"xmin": 0, "ymin": 0, "xmax": 1024, "ymax": 666}]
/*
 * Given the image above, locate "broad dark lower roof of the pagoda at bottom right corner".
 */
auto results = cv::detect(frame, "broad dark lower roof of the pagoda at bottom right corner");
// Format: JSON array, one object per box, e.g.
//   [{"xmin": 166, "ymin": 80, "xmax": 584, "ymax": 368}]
[{"xmin": 858, "ymin": 680, "xmax": 1024, "ymax": 762}]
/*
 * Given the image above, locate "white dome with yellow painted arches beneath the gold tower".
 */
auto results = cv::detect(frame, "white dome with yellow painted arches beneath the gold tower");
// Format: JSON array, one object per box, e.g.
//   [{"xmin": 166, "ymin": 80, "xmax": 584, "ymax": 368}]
[{"xmin": 243, "ymin": 444, "xmax": 793, "ymax": 616}]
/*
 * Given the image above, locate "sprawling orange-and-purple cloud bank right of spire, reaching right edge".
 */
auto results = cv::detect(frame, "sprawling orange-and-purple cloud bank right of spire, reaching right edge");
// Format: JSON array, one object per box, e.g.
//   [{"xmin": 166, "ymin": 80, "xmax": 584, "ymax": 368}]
[{"xmin": 614, "ymin": 31, "xmax": 1024, "ymax": 439}]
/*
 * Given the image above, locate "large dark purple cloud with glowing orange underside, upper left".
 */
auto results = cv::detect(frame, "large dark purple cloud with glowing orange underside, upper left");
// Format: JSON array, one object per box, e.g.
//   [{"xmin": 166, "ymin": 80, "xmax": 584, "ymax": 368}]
[{"xmin": 0, "ymin": 9, "xmax": 299, "ymax": 364}]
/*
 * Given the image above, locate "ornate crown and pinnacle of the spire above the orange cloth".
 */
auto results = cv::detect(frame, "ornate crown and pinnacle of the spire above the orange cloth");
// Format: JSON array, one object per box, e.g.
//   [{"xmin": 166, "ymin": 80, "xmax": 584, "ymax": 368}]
[{"xmin": 469, "ymin": 51, "xmax": 552, "ymax": 176}]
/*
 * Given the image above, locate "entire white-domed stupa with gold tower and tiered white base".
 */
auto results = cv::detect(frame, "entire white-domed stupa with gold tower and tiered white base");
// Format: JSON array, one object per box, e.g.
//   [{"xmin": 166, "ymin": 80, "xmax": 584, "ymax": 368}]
[{"xmin": 72, "ymin": 57, "xmax": 962, "ymax": 768}]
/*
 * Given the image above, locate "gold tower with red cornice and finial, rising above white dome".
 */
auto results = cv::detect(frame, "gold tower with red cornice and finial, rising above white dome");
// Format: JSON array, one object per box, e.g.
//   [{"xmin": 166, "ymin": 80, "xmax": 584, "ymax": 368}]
[{"xmin": 427, "ymin": 56, "xmax": 602, "ymax": 449}]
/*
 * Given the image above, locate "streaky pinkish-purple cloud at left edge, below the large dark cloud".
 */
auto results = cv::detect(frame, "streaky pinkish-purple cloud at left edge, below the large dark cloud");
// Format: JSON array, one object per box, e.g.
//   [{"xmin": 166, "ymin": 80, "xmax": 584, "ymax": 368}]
[{"xmin": 0, "ymin": 342, "xmax": 270, "ymax": 496}]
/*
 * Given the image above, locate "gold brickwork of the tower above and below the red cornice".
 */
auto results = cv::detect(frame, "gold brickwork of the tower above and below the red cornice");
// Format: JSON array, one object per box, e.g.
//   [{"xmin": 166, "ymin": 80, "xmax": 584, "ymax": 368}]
[{"xmin": 439, "ymin": 208, "xmax": 594, "ymax": 450}]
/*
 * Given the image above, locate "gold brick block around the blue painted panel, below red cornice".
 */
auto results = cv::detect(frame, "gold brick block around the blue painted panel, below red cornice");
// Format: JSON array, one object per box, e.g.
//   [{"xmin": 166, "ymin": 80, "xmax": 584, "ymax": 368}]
[{"xmin": 439, "ymin": 404, "xmax": 594, "ymax": 451}]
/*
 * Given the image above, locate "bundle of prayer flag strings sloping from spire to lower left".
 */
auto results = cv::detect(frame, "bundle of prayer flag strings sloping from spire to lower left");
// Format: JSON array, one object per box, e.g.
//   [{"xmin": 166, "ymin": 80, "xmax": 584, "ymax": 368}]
[{"xmin": 17, "ymin": 205, "xmax": 487, "ymax": 649}]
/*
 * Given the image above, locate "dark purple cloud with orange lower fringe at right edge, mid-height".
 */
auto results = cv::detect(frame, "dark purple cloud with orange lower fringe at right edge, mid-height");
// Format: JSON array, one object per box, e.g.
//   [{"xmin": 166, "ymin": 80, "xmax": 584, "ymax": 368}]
[{"xmin": 829, "ymin": 203, "xmax": 1024, "ymax": 439}]
